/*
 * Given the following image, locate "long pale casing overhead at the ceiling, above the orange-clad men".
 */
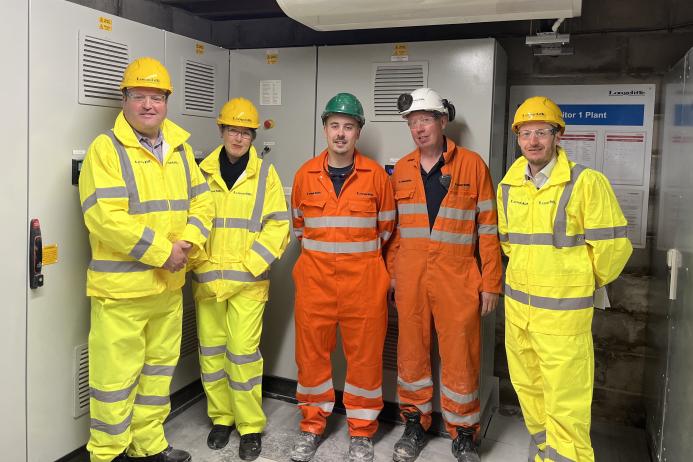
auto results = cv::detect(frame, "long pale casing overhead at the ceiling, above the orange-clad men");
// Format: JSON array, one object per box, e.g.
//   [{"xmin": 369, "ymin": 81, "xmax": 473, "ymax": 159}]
[{"xmin": 277, "ymin": 0, "xmax": 582, "ymax": 31}]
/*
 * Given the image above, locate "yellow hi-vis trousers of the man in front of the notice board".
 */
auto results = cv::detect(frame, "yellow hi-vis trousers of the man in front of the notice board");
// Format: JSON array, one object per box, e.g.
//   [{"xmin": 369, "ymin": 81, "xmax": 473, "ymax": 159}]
[{"xmin": 505, "ymin": 320, "xmax": 594, "ymax": 462}]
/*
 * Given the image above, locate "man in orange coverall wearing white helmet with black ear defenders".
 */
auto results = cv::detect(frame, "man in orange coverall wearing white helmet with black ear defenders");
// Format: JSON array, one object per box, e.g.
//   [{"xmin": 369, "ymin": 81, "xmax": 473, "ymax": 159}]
[{"xmin": 387, "ymin": 88, "xmax": 501, "ymax": 462}]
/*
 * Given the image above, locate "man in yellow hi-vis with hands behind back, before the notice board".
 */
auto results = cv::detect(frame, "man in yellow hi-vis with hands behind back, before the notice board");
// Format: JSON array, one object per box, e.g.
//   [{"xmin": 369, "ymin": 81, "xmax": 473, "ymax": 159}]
[{"xmin": 497, "ymin": 96, "xmax": 632, "ymax": 462}]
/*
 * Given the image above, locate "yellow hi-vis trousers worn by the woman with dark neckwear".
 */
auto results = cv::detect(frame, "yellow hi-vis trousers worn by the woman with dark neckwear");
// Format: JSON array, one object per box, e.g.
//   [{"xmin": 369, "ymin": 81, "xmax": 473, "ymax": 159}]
[{"xmin": 197, "ymin": 294, "xmax": 267, "ymax": 435}]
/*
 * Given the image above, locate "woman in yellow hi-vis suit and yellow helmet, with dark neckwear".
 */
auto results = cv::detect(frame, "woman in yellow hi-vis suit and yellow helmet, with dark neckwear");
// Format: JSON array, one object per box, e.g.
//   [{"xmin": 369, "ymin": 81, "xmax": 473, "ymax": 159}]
[{"xmin": 193, "ymin": 98, "xmax": 289, "ymax": 460}]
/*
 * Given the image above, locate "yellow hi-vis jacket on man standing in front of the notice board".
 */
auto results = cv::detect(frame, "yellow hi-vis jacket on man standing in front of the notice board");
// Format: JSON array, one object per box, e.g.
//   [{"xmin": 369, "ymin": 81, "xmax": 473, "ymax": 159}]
[{"xmin": 497, "ymin": 147, "xmax": 633, "ymax": 335}]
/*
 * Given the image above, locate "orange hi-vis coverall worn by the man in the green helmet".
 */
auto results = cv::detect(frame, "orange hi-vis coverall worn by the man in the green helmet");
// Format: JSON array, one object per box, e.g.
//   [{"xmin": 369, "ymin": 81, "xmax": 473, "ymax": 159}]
[{"xmin": 291, "ymin": 151, "xmax": 395, "ymax": 437}]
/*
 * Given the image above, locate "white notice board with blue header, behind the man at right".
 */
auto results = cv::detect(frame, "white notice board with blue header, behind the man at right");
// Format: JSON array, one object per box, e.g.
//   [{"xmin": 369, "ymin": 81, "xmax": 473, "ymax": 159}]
[{"xmin": 507, "ymin": 84, "xmax": 655, "ymax": 248}]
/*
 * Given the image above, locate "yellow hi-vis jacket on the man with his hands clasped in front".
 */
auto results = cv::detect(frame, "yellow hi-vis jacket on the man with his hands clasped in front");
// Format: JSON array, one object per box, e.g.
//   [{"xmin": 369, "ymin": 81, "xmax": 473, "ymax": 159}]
[{"xmin": 79, "ymin": 112, "xmax": 214, "ymax": 298}]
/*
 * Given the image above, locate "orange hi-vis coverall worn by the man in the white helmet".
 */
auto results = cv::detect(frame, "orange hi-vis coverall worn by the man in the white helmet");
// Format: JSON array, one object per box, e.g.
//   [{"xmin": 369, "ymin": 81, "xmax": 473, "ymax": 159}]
[{"xmin": 387, "ymin": 138, "xmax": 502, "ymax": 438}]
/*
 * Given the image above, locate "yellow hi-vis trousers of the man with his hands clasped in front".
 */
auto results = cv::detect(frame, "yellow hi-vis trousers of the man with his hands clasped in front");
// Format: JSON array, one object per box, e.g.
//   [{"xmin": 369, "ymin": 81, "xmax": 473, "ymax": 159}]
[{"xmin": 87, "ymin": 290, "xmax": 183, "ymax": 462}]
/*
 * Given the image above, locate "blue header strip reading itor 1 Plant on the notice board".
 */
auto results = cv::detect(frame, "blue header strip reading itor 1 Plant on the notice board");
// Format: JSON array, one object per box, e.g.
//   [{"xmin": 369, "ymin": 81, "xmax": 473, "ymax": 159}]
[{"xmin": 559, "ymin": 104, "xmax": 645, "ymax": 127}]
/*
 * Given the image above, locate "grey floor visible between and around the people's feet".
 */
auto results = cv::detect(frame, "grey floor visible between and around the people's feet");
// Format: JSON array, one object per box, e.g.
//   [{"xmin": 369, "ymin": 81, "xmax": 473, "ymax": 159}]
[{"xmin": 166, "ymin": 398, "xmax": 650, "ymax": 462}]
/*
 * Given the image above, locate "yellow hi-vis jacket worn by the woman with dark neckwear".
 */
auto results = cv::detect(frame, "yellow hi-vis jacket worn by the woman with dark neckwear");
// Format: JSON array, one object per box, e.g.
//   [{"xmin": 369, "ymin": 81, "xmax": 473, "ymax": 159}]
[{"xmin": 191, "ymin": 146, "xmax": 289, "ymax": 301}]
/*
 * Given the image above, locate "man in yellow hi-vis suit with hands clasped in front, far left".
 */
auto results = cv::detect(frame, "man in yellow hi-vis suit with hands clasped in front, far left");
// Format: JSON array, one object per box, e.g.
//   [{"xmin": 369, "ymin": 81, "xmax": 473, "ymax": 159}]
[{"xmin": 79, "ymin": 58, "xmax": 214, "ymax": 462}]
